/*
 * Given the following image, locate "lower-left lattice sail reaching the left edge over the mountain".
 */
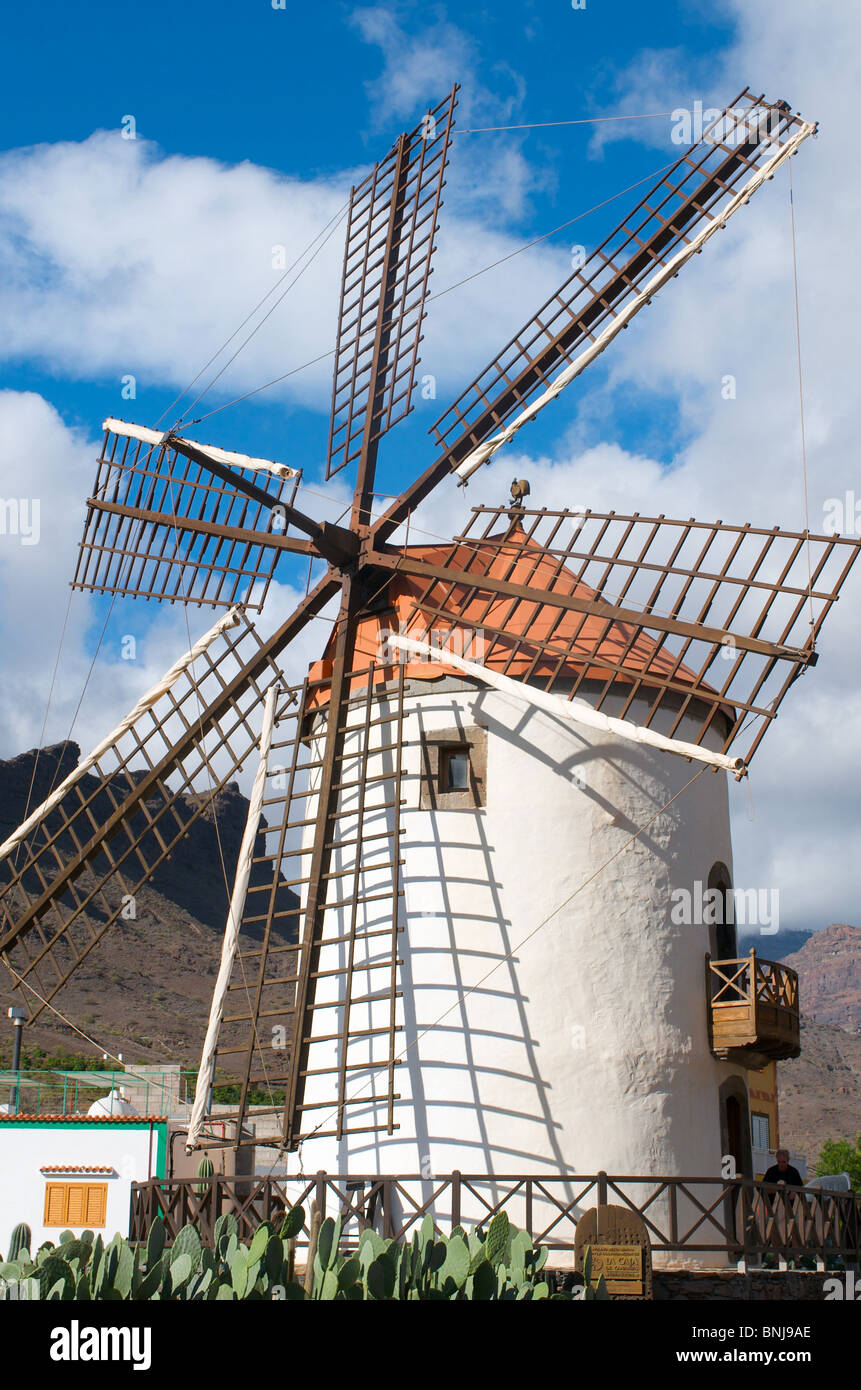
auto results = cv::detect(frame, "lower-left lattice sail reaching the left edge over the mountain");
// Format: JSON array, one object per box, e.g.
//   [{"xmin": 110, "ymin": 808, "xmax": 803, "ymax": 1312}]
[{"xmin": 0, "ymin": 612, "xmax": 289, "ymax": 1017}]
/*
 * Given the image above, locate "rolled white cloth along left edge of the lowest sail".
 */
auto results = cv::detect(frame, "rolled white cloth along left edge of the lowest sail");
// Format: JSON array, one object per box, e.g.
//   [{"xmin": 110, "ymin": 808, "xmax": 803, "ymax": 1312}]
[{"xmin": 185, "ymin": 685, "xmax": 277, "ymax": 1154}]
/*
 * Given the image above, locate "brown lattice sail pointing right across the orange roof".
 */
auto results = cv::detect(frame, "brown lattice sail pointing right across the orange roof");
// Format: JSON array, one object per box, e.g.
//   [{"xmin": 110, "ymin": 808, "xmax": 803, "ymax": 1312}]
[{"xmin": 370, "ymin": 507, "xmax": 861, "ymax": 767}]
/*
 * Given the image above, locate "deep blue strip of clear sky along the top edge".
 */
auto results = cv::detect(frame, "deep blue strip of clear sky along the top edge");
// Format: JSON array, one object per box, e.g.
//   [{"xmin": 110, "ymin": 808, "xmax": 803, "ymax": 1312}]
[{"xmin": 3, "ymin": 0, "xmax": 733, "ymax": 166}]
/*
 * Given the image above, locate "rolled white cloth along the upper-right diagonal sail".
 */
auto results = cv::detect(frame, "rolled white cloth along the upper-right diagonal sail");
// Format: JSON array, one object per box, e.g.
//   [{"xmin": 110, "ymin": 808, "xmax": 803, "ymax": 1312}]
[{"xmin": 453, "ymin": 121, "xmax": 816, "ymax": 487}]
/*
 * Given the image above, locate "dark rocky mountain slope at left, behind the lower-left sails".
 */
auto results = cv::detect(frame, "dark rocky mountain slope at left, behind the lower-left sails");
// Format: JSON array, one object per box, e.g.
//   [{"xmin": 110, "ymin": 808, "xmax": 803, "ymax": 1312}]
[{"xmin": 0, "ymin": 742, "xmax": 296, "ymax": 1065}]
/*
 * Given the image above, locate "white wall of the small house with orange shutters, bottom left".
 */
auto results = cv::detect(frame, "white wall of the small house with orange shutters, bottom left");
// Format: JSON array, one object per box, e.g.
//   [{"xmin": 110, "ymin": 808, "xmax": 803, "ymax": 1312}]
[{"xmin": 0, "ymin": 1119, "xmax": 164, "ymax": 1255}]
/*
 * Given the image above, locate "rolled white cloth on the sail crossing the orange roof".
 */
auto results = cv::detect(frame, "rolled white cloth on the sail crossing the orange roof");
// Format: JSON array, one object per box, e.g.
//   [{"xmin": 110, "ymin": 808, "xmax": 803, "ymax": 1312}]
[{"xmin": 387, "ymin": 632, "xmax": 747, "ymax": 778}]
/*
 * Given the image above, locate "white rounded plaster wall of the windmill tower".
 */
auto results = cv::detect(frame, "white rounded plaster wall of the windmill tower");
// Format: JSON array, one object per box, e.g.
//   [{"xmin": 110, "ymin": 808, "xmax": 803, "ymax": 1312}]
[{"xmin": 293, "ymin": 681, "xmax": 746, "ymax": 1267}]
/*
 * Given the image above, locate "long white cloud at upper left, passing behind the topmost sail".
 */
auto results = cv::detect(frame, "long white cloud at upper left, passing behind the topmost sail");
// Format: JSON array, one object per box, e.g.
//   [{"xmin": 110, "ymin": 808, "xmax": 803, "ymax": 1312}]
[{"xmin": 0, "ymin": 132, "xmax": 561, "ymax": 428}]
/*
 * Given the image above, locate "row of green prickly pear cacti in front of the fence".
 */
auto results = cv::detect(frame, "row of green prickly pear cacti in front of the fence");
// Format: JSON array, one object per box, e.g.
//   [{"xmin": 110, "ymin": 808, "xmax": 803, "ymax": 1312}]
[{"xmin": 0, "ymin": 1206, "xmax": 592, "ymax": 1302}]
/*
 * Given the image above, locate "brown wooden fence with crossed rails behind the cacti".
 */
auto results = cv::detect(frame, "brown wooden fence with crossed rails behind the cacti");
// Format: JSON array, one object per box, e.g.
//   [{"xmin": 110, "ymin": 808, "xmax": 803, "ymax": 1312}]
[{"xmin": 129, "ymin": 1172, "xmax": 861, "ymax": 1265}]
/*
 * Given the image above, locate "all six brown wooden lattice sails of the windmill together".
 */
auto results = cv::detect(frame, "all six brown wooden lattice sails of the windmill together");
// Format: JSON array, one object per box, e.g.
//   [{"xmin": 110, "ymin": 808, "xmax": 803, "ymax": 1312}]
[{"xmin": 0, "ymin": 88, "xmax": 860, "ymax": 1148}]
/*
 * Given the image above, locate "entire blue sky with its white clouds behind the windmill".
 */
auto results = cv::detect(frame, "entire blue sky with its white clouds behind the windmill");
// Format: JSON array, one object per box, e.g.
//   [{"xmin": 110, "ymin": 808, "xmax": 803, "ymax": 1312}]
[{"xmin": 0, "ymin": 0, "xmax": 861, "ymax": 926}]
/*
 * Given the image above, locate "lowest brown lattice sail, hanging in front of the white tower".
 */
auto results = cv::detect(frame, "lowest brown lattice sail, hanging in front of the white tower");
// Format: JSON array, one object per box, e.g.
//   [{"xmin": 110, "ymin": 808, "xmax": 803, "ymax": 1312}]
[{"xmin": 216, "ymin": 657, "xmax": 403, "ymax": 1148}]
